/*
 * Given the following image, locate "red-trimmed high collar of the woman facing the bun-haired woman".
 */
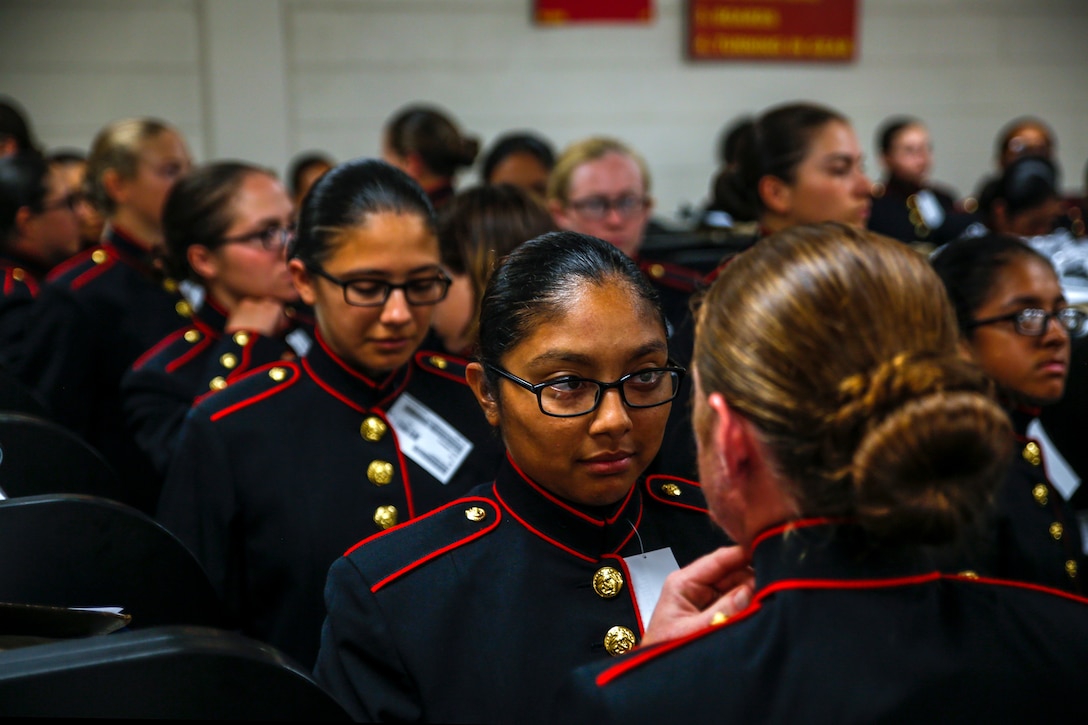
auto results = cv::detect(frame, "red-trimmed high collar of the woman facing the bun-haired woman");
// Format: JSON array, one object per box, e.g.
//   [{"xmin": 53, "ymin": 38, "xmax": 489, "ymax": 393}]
[{"xmin": 495, "ymin": 455, "xmax": 643, "ymax": 561}]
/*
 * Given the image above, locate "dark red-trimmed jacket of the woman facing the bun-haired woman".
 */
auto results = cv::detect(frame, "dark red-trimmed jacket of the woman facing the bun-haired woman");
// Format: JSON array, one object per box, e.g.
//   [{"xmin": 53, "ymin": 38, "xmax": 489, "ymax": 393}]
[{"xmin": 314, "ymin": 460, "xmax": 726, "ymax": 723}]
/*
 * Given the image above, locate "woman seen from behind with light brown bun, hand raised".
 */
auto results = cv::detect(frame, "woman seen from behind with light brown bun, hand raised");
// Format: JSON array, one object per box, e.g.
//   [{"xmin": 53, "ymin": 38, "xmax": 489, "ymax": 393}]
[{"xmin": 545, "ymin": 224, "xmax": 1088, "ymax": 723}]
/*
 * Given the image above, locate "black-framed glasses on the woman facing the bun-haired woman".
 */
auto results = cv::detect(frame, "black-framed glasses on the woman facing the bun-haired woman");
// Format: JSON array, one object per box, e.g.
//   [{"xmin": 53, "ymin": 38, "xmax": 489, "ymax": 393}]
[{"xmin": 485, "ymin": 364, "xmax": 688, "ymax": 418}]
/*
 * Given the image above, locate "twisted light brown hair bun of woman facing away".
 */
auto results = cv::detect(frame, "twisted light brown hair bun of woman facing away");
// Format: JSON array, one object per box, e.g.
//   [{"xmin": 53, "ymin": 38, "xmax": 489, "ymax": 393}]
[{"xmin": 832, "ymin": 354, "xmax": 1012, "ymax": 544}]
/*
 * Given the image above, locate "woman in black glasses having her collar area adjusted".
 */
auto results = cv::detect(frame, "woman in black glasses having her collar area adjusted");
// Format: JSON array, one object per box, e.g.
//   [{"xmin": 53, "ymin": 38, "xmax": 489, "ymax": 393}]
[{"xmin": 314, "ymin": 232, "xmax": 725, "ymax": 723}]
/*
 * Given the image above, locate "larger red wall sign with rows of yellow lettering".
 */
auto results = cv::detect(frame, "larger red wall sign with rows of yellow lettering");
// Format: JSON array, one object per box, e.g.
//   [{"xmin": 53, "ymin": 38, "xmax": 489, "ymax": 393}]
[{"xmin": 688, "ymin": 0, "xmax": 857, "ymax": 62}]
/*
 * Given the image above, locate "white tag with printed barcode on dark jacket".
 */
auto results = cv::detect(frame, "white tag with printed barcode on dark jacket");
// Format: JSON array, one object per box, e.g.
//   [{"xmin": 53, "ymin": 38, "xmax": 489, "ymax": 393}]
[{"xmin": 385, "ymin": 393, "xmax": 472, "ymax": 483}]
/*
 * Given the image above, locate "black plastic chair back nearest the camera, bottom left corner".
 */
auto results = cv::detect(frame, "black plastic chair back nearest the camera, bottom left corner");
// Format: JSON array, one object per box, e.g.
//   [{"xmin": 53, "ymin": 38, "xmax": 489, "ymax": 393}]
[{"xmin": 0, "ymin": 627, "xmax": 349, "ymax": 722}]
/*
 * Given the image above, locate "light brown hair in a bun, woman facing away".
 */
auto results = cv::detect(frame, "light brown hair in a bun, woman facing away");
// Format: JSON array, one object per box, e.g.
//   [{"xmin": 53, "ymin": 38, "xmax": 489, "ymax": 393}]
[{"xmin": 693, "ymin": 222, "xmax": 1012, "ymax": 543}]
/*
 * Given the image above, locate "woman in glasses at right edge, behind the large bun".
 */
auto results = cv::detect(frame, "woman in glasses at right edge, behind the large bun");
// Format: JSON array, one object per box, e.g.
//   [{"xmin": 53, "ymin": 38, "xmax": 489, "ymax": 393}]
[{"xmin": 934, "ymin": 234, "xmax": 1085, "ymax": 593}]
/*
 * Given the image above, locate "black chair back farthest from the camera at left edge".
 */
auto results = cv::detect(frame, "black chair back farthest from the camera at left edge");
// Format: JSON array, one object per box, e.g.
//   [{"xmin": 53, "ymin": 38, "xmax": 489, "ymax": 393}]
[{"xmin": 0, "ymin": 413, "xmax": 125, "ymax": 501}]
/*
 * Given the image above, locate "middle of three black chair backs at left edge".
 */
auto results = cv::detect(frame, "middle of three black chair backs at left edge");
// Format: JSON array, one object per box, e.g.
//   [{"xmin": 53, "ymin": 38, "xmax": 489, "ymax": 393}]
[{"xmin": 0, "ymin": 494, "xmax": 225, "ymax": 635}]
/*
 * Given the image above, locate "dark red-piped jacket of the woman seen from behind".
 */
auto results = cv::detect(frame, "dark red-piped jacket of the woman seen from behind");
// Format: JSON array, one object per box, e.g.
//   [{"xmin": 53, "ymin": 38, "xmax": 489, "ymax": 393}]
[{"xmin": 557, "ymin": 521, "xmax": 1088, "ymax": 725}]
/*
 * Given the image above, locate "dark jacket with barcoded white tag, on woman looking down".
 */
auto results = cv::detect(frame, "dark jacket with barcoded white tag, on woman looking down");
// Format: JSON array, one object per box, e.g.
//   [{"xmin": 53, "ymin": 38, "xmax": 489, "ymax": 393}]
[{"xmin": 159, "ymin": 336, "xmax": 502, "ymax": 666}]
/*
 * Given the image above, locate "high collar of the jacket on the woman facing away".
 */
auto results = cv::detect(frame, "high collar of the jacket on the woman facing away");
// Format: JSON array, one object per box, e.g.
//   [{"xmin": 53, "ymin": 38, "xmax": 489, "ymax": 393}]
[{"xmin": 752, "ymin": 518, "xmax": 935, "ymax": 591}]
